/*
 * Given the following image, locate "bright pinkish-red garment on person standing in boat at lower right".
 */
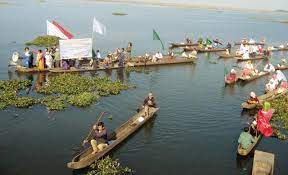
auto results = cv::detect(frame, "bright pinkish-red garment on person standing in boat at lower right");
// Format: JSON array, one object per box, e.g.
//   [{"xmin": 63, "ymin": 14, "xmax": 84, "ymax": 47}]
[{"xmin": 257, "ymin": 109, "xmax": 273, "ymax": 137}]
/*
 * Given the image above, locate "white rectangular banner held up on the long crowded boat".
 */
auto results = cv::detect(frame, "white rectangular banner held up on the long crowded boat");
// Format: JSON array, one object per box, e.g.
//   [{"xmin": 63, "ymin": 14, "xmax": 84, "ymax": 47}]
[{"xmin": 59, "ymin": 38, "xmax": 92, "ymax": 59}]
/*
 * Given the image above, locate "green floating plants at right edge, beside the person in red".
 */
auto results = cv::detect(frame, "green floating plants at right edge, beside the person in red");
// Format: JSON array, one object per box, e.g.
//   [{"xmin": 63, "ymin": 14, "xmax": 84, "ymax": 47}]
[{"xmin": 271, "ymin": 96, "xmax": 288, "ymax": 139}]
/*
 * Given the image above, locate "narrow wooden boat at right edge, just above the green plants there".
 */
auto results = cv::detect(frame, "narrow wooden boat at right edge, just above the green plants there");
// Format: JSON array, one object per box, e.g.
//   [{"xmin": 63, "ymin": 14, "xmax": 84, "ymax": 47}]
[{"xmin": 241, "ymin": 89, "xmax": 288, "ymax": 109}]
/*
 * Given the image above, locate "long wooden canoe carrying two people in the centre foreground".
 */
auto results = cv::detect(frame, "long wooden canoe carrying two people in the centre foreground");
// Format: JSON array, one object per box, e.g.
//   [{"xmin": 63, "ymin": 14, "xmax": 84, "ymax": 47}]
[{"xmin": 67, "ymin": 108, "xmax": 159, "ymax": 169}]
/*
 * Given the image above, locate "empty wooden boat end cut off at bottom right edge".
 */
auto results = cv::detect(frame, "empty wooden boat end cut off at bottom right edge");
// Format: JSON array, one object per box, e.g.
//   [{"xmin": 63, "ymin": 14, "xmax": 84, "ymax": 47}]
[{"xmin": 252, "ymin": 150, "xmax": 275, "ymax": 175}]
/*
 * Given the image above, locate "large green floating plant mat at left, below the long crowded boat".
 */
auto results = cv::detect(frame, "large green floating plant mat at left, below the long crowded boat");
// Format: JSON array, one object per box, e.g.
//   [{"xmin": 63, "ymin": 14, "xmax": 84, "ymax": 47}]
[{"xmin": 0, "ymin": 74, "xmax": 132, "ymax": 111}]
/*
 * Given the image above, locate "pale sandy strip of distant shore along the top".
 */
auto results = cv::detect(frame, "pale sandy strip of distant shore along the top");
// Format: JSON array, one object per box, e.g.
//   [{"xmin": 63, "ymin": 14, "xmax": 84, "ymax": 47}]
[{"xmin": 81, "ymin": 0, "xmax": 281, "ymax": 12}]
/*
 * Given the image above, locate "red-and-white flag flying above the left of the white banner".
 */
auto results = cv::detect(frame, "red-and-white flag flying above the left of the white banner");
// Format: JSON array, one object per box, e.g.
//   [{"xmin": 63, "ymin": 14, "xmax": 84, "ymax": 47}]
[{"xmin": 46, "ymin": 20, "xmax": 73, "ymax": 39}]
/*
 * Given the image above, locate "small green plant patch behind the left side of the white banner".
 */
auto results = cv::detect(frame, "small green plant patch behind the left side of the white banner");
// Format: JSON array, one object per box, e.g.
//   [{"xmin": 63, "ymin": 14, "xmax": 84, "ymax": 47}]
[{"xmin": 26, "ymin": 35, "xmax": 60, "ymax": 47}]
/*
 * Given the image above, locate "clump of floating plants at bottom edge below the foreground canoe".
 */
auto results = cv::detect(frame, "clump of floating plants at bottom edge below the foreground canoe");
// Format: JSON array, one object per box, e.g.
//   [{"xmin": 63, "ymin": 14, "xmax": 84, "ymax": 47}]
[{"xmin": 86, "ymin": 156, "xmax": 133, "ymax": 175}]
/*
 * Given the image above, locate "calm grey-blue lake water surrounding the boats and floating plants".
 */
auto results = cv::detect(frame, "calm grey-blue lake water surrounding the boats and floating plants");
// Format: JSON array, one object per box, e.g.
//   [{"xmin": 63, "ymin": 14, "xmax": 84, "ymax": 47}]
[{"xmin": 0, "ymin": 1, "xmax": 288, "ymax": 175}]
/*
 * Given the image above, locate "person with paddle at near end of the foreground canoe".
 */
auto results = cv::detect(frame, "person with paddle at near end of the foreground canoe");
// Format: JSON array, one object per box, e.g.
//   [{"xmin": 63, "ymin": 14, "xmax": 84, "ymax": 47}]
[{"xmin": 84, "ymin": 122, "xmax": 108, "ymax": 154}]
